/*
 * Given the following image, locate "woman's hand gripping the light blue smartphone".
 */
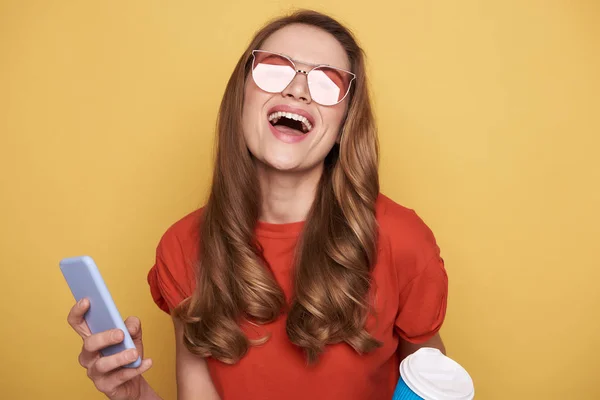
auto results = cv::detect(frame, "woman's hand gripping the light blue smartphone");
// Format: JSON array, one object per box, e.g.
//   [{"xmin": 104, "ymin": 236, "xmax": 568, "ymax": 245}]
[{"xmin": 67, "ymin": 299, "xmax": 152, "ymax": 400}]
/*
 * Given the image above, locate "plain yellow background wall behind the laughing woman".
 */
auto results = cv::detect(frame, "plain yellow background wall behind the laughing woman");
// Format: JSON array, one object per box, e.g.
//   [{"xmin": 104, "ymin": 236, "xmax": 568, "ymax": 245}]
[{"xmin": 0, "ymin": 0, "xmax": 600, "ymax": 400}]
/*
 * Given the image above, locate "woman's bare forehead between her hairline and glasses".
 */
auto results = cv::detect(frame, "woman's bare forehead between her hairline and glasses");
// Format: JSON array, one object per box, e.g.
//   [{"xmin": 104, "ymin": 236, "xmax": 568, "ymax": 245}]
[{"xmin": 261, "ymin": 24, "xmax": 350, "ymax": 70}]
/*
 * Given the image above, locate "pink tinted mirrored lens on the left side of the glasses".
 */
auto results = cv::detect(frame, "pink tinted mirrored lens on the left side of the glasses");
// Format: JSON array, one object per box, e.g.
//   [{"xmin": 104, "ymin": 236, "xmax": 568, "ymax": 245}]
[{"xmin": 252, "ymin": 51, "xmax": 296, "ymax": 93}]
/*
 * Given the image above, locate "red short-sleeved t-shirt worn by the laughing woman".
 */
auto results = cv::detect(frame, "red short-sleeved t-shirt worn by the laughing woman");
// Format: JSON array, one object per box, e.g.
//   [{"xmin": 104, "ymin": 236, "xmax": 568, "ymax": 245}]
[{"xmin": 148, "ymin": 195, "xmax": 448, "ymax": 400}]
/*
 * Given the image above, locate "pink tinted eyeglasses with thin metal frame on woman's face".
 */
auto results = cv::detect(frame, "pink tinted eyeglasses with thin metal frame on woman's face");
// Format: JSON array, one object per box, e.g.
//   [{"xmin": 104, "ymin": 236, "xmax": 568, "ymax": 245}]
[{"xmin": 252, "ymin": 50, "xmax": 356, "ymax": 106}]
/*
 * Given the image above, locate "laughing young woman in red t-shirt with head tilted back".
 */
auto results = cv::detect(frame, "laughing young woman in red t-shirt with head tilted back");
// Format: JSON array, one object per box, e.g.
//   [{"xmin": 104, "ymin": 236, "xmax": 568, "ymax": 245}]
[{"xmin": 69, "ymin": 11, "xmax": 448, "ymax": 400}]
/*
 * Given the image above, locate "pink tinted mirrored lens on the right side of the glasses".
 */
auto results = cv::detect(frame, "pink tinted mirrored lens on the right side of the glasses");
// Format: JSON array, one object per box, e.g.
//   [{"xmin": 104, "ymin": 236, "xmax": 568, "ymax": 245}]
[{"xmin": 308, "ymin": 67, "xmax": 351, "ymax": 106}]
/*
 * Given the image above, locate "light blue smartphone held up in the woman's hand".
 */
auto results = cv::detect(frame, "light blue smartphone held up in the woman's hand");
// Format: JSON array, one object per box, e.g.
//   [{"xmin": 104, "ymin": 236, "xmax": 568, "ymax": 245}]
[{"xmin": 60, "ymin": 256, "xmax": 142, "ymax": 368}]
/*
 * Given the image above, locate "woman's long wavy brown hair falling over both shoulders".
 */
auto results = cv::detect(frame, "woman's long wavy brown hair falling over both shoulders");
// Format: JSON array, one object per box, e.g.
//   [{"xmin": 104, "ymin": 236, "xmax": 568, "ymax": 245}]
[{"xmin": 175, "ymin": 10, "xmax": 381, "ymax": 363}]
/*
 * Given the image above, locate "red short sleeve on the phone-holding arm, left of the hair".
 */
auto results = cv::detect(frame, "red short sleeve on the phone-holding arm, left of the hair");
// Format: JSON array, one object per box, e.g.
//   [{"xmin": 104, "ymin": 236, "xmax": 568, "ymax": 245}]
[{"xmin": 148, "ymin": 214, "xmax": 197, "ymax": 314}]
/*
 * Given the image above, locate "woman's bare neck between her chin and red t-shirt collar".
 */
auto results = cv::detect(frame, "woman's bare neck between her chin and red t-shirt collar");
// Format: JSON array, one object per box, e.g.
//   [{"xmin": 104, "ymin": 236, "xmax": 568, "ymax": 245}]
[{"xmin": 257, "ymin": 164, "xmax": 323, "ymax": 224}]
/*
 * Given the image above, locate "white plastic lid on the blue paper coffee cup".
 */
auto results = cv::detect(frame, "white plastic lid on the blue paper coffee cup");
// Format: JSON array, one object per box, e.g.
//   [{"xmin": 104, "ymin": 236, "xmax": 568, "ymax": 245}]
[{"xmin": 400, "ymin": 347, "xmax": 475, "ymax": 400}]
